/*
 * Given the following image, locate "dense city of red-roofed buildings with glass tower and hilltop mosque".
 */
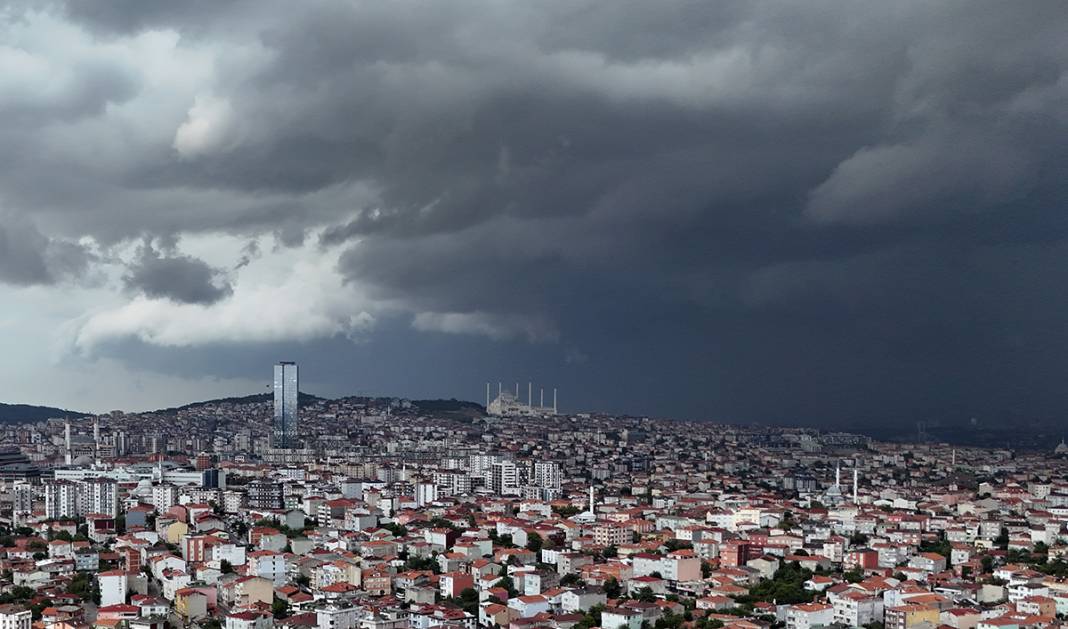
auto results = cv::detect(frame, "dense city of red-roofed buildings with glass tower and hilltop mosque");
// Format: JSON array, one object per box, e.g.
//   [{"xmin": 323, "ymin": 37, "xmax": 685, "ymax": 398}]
[{"xmin": 0, "ymin": 363, "xmax": 1068, "ymax": 629}]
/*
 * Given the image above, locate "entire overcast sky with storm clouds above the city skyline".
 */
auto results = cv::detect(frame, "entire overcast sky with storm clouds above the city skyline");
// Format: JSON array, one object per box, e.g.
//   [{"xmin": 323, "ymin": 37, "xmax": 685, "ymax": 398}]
[{"xmin": 0, "ymin": 0, "xmax": 1068, "ymax": 426}]
